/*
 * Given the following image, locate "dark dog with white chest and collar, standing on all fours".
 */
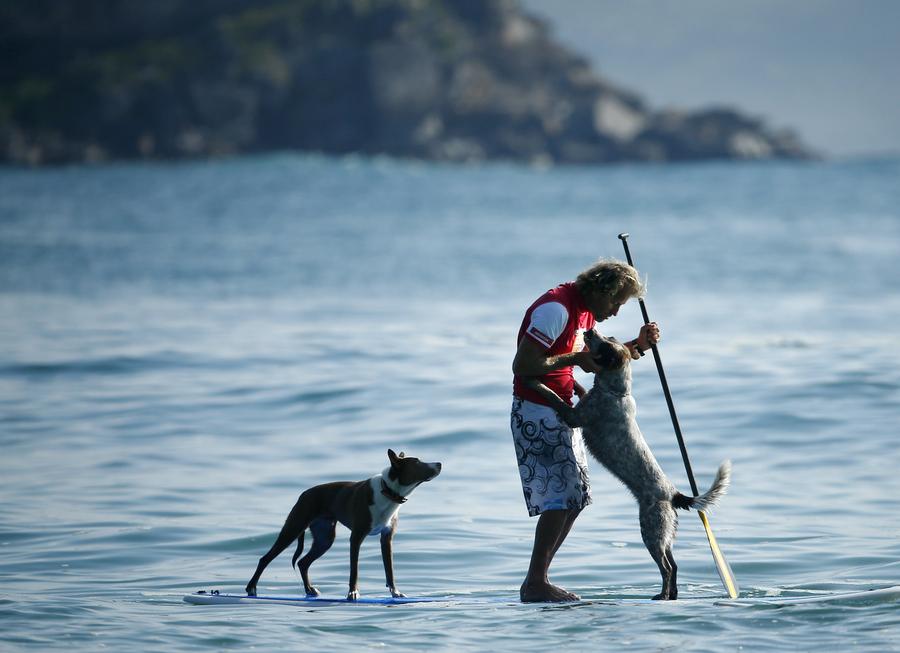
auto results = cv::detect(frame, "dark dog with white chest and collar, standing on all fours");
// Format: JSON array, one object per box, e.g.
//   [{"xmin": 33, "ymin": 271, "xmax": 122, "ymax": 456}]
[{"xmin": 246, "ymin": 449, "xmax": 441, "ymax": 601}]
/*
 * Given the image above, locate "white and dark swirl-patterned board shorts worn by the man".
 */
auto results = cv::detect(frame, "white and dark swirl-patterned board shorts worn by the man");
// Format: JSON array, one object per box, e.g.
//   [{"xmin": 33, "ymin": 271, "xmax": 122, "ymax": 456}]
[{"xmin": 510, "ymin": 397, "xmax": 591, "ymax": 517}]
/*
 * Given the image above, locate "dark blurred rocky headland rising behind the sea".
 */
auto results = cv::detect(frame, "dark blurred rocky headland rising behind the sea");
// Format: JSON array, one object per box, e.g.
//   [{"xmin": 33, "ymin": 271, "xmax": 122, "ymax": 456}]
[{"xmin": 0, "ymin": 0, "xmax": 810, "ymax": 165}]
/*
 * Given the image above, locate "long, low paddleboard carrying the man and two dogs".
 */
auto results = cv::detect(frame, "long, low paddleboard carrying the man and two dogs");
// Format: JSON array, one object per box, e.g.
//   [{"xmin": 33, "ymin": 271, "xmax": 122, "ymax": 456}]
[{"xmin": 184, "ymin": 585, "xmax": 900, "ymax": 607}]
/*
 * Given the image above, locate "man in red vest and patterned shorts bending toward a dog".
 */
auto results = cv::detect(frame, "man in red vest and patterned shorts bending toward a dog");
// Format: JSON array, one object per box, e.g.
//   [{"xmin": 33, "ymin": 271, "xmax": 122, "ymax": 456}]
[{"xmin": 511, "ymin": 259, "xmax": 659, "ymax": 602}]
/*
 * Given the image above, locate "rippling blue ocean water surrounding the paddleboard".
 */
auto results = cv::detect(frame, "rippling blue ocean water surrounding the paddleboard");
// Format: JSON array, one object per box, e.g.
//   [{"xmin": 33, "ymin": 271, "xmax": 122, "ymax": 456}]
[{"xmin": 0, "ymin": 155, "xmax": 900, "ymax": 651}]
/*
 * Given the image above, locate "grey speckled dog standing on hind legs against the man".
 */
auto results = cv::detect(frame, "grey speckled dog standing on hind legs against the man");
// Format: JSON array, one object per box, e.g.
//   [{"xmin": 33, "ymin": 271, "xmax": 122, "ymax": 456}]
[{"xmin": 533, "ymin": 331, "xmax": 731, "ymax": 599}]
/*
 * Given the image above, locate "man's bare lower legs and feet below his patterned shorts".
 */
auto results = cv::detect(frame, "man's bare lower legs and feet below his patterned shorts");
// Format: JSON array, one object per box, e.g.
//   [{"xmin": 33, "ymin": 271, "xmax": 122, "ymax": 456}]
[{"xmin": 519, "ymin": 510, "xmax": 581, "ymax": 603}]
